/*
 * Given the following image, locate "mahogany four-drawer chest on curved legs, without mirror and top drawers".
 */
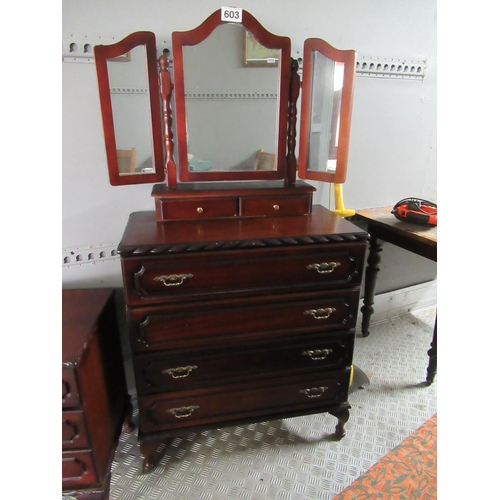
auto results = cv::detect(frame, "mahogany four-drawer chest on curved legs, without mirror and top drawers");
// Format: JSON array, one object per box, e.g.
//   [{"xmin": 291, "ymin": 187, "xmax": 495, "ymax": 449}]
[{"xmin": 118, "ymin": 206, "xmax": 368, "ymax": 470}]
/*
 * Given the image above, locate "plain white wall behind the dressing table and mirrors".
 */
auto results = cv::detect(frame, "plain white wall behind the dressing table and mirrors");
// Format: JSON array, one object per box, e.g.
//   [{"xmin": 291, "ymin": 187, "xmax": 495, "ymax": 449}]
[{"xmin": 62, "ymin": 0, "xmax": 437, "ymax": 290}]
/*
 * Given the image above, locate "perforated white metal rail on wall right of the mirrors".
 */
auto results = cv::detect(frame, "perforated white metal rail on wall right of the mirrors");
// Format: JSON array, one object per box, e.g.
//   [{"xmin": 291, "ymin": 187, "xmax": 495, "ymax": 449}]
[{"xmin": 356, "ymin": 56, "xmax": 427, "ymax": 80}]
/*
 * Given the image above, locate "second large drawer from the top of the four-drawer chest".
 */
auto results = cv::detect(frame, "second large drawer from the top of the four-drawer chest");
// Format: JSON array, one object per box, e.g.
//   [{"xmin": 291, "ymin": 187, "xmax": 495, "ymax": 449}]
[{"xmin": 127, "ymin": 290, "xmax": 359, "ymax": 352}]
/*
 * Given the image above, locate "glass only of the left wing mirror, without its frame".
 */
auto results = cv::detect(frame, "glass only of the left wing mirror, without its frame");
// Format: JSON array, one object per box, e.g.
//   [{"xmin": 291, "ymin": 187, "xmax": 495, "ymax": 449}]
[{"xmin": 107, "ymin": 45, "xmax": 155, "ymax": 176}]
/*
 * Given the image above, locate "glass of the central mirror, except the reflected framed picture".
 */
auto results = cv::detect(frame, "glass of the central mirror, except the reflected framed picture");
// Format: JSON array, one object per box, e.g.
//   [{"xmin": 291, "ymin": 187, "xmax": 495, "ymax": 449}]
[{"xmin": 183, "ymin": 24, "xmax": 281, "ymax": 172}]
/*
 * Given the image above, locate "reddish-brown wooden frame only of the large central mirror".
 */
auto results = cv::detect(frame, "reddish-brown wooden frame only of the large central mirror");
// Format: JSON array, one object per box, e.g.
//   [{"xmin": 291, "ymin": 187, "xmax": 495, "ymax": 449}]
[{"xmin": 172, "ymin": 9, "xmax": 291, "ymax": 182}]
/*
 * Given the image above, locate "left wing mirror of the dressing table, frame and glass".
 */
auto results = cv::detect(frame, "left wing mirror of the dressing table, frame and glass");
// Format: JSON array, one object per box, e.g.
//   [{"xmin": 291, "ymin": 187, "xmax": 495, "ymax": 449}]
[{"xmin": 94, "ymin": 31, "xmax": 165, "ymax": 186}]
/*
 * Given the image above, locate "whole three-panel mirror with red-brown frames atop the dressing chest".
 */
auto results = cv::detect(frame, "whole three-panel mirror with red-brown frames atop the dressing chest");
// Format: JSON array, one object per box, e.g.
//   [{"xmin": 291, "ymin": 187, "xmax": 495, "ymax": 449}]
[{"xmin": 95, "ymin": 9, "xmax": 355, "ymax": 189}]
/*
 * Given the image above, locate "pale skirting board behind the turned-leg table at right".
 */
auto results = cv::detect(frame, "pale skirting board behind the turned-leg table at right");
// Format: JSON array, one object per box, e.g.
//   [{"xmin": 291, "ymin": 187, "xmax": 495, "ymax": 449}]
[{"xmin": 356, "ymin": 280, "xmax": 437, "ymax": 330}]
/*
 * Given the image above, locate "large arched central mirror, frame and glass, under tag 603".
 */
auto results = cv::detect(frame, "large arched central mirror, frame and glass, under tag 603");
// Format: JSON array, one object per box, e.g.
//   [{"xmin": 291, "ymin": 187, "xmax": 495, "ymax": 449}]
[{"xmin": 172, "ymin": 11, "xmax": 290, "ymax": 182}]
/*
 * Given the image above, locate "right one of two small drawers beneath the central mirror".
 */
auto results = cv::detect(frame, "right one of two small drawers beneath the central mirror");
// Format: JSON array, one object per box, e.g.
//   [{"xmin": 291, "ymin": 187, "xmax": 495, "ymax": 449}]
[{"xmin": 240, "ymin": 194, "xmax": 312, "ymax": 217}]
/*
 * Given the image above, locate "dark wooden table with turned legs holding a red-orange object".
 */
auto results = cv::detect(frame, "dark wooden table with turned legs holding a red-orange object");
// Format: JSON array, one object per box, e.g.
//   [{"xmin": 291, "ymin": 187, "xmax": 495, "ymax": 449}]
[{"xmin": 356, "ymin": 206, "xmax": 437, "ymax": 384}]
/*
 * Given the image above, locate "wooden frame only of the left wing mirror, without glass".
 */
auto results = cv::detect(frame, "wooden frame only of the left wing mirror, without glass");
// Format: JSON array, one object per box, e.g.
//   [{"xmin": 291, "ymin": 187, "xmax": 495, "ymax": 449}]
[{"xmin": 94, "ymin": 31, "xmax": 165, "ymax": 186}]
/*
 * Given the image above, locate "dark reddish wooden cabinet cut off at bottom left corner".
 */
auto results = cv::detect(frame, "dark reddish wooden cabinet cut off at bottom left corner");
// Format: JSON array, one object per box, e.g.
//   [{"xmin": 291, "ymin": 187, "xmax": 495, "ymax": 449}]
[{"xmin": 62, "ymin": 289, "xmax": 133, "ymax": 500}]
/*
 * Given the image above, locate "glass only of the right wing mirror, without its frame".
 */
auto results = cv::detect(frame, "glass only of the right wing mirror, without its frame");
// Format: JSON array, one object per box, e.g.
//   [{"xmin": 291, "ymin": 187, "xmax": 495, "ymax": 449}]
[{"xmin": 307, "ymin": 51, "xmax": 344, "ymax": 173}]
